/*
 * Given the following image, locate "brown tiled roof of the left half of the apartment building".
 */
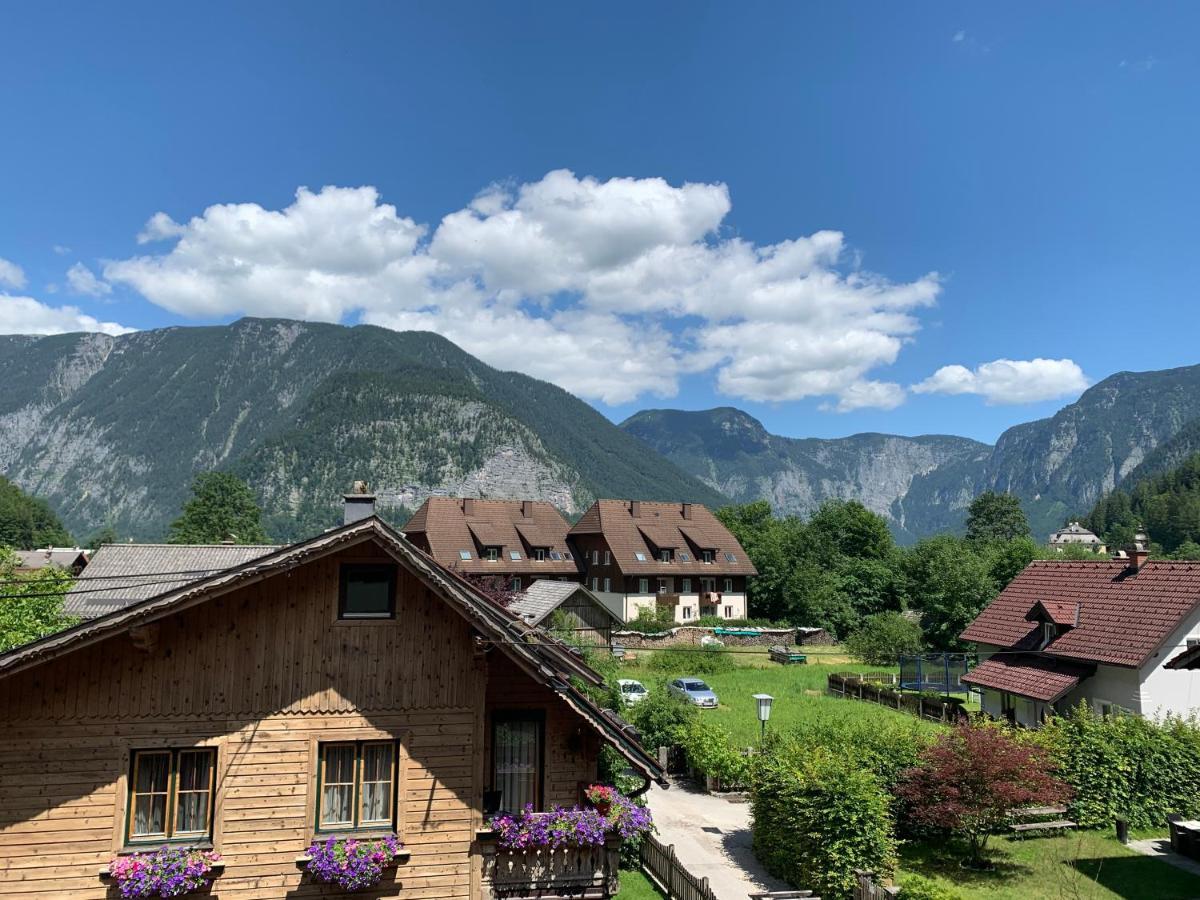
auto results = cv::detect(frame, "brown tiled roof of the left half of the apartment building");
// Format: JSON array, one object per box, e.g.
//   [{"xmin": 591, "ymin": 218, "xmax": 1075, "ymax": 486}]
[{"xmin": 402, "ymin": 497, "xmax": 578, "ymax": 575}]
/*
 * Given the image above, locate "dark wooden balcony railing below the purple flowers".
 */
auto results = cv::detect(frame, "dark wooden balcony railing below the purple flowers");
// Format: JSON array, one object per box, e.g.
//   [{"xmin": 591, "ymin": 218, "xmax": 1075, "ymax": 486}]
[{"xmin": 478, "ymin": 832, "xmax": 620, "ymax": 900}]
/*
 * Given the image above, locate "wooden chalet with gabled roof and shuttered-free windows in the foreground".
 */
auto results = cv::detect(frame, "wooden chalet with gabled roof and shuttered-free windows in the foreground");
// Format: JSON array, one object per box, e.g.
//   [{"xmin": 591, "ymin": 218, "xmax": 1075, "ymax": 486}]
[{"xmin": 0, "ymin": 516, "xmax": 662, "ymax": 900}]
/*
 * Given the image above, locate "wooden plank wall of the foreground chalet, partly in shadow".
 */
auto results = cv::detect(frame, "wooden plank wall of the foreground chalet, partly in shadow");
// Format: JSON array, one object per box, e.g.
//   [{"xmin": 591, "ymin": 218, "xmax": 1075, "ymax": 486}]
[{"xmin": 0, "ymin": 553, "xmax": 496, "ymax": 900}]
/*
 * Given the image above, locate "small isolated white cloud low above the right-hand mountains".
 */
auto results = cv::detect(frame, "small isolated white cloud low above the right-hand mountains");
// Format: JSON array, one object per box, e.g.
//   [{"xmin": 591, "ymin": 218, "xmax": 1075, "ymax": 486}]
[{"xmin": 912, "ymin": 359, "xmax": 1088, "ymax": 404}]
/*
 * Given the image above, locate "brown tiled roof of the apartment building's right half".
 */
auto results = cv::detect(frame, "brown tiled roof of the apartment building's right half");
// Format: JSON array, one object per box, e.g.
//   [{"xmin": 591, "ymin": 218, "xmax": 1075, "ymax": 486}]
[{"xmin": 570, "ymin": 500, "xmax": 758, "ymax": 575}]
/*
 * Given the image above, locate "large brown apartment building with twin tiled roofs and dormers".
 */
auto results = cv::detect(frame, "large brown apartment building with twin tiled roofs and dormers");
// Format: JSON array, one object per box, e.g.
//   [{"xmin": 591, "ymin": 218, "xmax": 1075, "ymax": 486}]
[{"xmin": 403, "ymin": 497, "xmax": 757, "ymax": 623}]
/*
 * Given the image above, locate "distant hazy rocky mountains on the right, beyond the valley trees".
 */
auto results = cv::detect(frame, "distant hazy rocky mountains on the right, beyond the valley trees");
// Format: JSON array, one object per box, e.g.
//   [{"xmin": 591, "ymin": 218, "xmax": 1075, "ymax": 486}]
[{"xmin": 622, "ymin": 366, "xmax": 1200, "ymax": 540}]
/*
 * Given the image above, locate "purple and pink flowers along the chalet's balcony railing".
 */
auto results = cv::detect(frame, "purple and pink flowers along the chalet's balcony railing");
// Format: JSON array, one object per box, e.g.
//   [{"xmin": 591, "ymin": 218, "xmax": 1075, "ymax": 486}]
[{"xmin": 490, "ymin": 785, "xmax": 652, "ymax": 850}]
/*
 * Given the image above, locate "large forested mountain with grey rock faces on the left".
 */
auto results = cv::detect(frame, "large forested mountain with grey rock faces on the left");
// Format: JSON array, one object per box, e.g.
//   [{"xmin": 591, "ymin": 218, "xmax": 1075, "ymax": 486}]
[{"xmin": 0, "ymin": 319, "xmax": 724, "ymax": 539}]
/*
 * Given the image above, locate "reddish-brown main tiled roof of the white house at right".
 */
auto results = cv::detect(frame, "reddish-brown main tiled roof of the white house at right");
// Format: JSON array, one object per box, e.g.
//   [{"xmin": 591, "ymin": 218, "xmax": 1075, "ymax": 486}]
[{"xmin": 962, "ymin": 559, "xmax": 1200, "ymax": 666}]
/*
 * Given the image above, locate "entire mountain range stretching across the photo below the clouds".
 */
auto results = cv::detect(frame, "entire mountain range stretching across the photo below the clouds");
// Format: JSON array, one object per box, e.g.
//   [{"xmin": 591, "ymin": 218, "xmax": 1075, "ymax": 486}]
[{"xmin": 0, "ymin": 318, "xmax": 1200, "ymax": 542}]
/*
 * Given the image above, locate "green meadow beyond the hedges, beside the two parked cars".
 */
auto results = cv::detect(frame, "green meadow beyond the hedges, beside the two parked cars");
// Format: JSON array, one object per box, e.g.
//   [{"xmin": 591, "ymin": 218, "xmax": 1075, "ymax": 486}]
[{"xmin": 620, "ymin": 647, "xmax": 931, "ymax": 746}]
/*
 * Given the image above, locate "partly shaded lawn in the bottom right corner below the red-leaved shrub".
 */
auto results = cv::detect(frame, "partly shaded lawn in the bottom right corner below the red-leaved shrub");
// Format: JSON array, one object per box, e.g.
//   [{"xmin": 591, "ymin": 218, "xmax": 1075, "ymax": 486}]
[{"xmin": 899, "ymin": 832, "xmax": 1200, "ymax": 900}]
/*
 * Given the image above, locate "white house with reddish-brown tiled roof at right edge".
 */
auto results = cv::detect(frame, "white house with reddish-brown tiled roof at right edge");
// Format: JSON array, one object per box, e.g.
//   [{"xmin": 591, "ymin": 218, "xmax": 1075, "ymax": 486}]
[{"xmin": 962, "ymin": 550, "xmax": 1200, "ymax": 726}]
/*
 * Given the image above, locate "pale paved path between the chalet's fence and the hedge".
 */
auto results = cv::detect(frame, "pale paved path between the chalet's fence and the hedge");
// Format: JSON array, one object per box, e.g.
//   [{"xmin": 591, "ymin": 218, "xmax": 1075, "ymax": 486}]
[{"xmin": 646, "ymin": 782, "xmax": 787, "ymax": 900}]
